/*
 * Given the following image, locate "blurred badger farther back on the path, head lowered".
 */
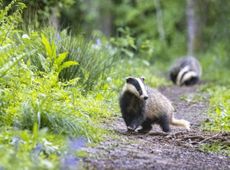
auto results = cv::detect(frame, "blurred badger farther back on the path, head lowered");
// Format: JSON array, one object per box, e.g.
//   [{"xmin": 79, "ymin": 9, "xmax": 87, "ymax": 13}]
[{"xmin": 169, "ymin": 56, "xmax": 201, "ymax": 86}]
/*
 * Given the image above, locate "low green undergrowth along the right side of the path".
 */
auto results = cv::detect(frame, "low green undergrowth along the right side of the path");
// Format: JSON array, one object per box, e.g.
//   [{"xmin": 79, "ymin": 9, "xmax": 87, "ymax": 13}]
[{"xmin": 201, "ymin": 51, "xmax": 230, "ymax": 156}]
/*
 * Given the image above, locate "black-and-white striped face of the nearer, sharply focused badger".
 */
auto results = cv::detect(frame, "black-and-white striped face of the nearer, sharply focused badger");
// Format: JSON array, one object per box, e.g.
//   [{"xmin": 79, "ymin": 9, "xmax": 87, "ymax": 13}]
[{"xmin": 123, "ymin": 77, "xmax": 148, "ymax": 100}]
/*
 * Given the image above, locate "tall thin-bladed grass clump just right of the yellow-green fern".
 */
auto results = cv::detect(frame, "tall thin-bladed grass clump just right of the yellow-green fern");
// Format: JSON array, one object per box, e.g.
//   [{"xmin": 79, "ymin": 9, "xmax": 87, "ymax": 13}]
[{"xmin": 56, "ymin": 31, "xmax": 116, "ymax": 91}]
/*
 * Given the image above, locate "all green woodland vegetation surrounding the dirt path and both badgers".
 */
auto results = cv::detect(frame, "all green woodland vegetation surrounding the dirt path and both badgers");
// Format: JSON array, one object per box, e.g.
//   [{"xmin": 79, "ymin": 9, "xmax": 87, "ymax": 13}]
[{"xmin": 0, "ymin": 0, "xmax": 230, "ymax": 169}]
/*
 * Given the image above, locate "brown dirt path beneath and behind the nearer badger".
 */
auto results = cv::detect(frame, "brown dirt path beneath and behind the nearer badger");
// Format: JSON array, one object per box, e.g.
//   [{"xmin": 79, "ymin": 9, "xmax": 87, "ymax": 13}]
[{"xmin": 83, "ymin": 86, "xmax": 230, "ymax": 170}]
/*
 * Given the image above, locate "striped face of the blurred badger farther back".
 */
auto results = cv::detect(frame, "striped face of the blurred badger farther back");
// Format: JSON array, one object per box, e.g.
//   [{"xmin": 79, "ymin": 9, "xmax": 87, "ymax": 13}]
[{"xmin": 176, "ymin": 66, "xmax": 198, "ymax": 86}]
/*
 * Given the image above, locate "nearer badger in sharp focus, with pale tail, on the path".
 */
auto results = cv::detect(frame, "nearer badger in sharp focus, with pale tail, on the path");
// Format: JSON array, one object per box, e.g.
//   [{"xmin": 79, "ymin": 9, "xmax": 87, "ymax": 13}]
[{"xmin": 119, "ymin": 77, "xmax": 190, "ymax": 133}]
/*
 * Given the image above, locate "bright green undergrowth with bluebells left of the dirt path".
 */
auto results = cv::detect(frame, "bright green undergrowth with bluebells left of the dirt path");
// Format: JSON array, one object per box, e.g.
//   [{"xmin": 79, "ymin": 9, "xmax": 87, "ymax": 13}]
[{"xmin": 0, "ymin": 0, "xmax": 117, "ymax": 169}]
